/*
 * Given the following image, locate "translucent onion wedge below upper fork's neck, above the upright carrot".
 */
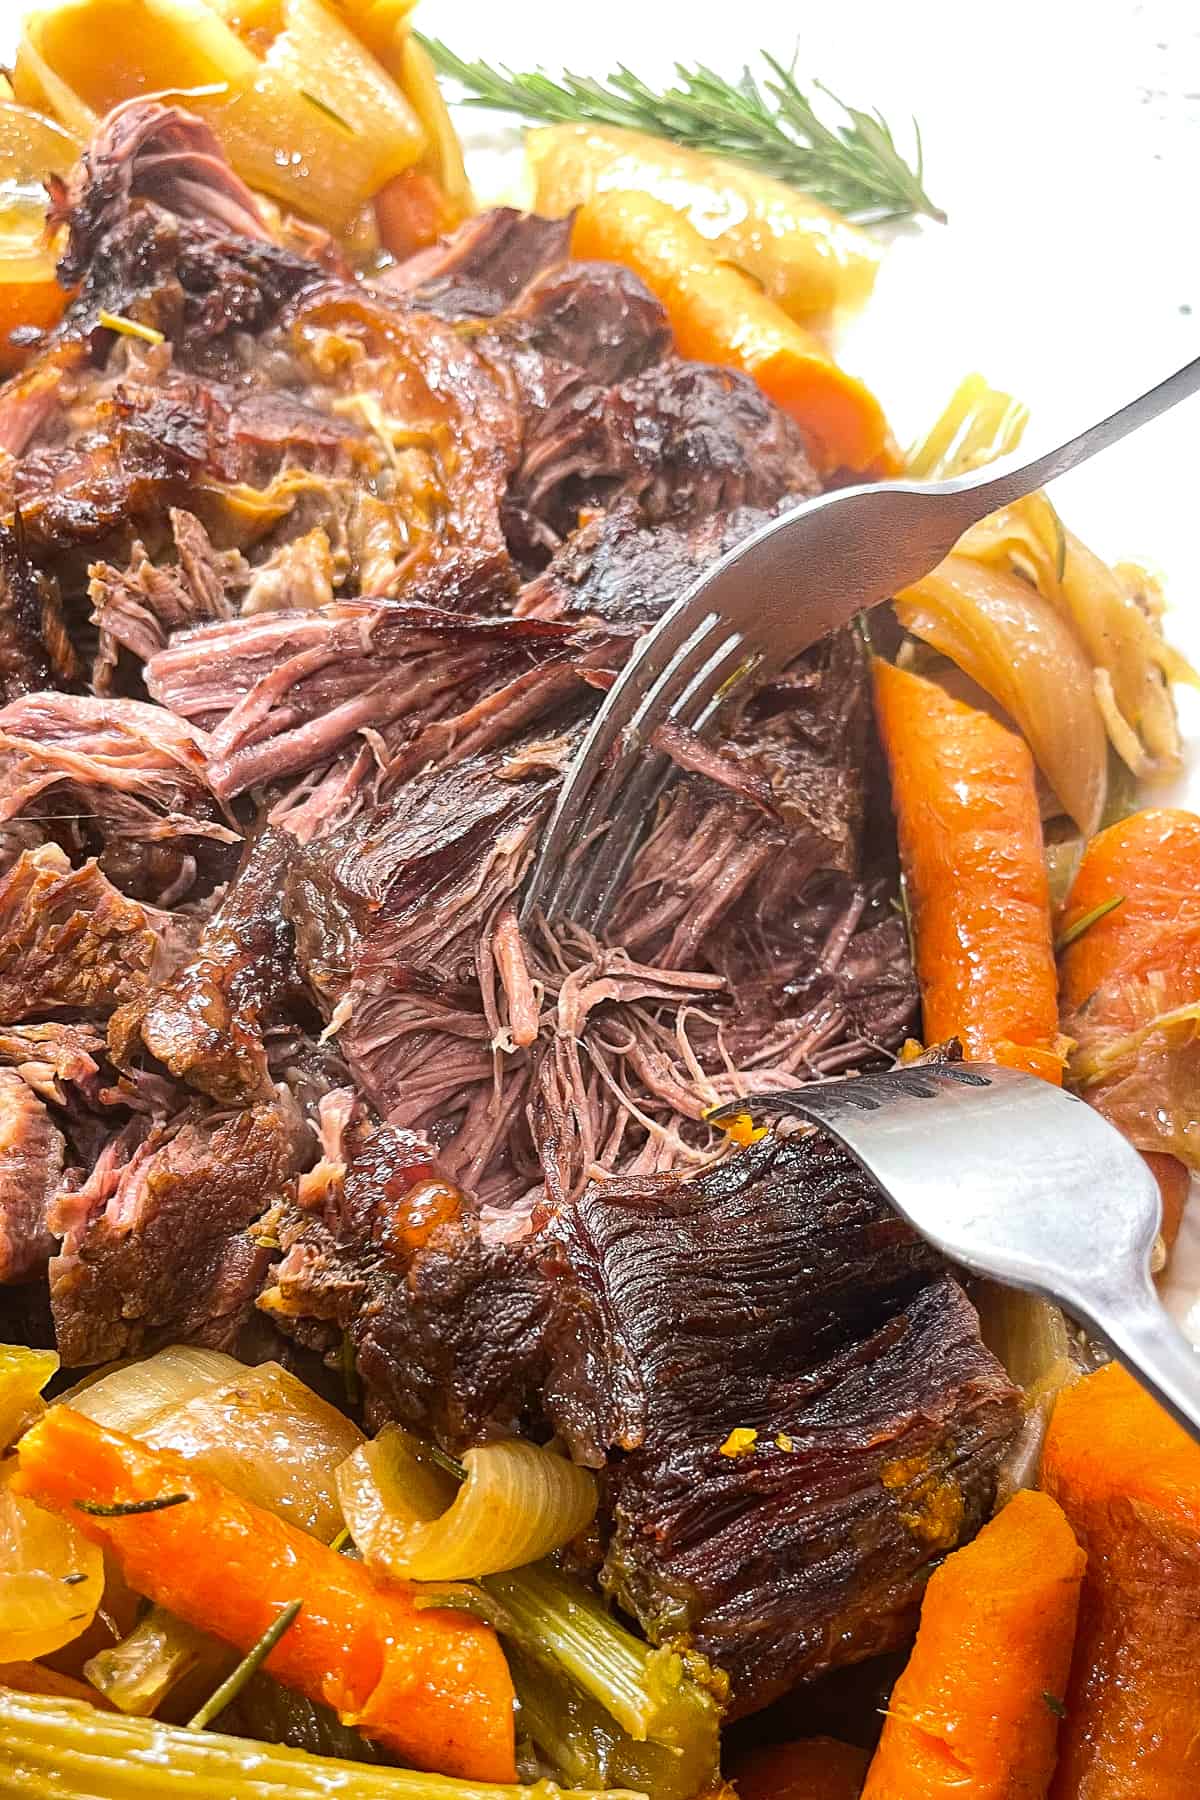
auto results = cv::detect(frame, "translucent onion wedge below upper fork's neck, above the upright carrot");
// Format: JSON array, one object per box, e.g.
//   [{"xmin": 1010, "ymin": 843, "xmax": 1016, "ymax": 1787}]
[{"xmin": 896, "ymin": 550, "xmax": 1108, "ymax": 835}]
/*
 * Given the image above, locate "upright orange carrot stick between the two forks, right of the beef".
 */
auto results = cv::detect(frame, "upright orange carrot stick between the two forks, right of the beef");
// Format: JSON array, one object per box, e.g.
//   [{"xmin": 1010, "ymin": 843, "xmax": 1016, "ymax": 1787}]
[{"xmin": 874, "ymin": 661, "xmax": 1063, "ymax": 1082}]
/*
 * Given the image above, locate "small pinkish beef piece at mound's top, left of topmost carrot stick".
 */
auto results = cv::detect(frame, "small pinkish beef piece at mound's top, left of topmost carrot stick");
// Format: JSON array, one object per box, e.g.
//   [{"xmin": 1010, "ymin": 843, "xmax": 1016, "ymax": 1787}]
[{"xmin": 381, "ymin": 207, "xmax": 570, "ymax": 319}]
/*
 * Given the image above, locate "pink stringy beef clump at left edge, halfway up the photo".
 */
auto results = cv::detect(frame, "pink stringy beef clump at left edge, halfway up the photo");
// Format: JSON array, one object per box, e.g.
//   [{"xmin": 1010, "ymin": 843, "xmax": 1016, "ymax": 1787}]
[{"xmin": 0, "ymin": 693, "xmax": 239, "ymax": 905}]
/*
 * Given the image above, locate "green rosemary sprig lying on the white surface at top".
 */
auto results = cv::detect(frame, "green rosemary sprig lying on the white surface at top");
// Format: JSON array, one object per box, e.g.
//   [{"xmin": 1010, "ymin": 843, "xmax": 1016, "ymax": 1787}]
[{"xmin": 417, "ymin": 34, "xmax": 945, "ymax": 220}]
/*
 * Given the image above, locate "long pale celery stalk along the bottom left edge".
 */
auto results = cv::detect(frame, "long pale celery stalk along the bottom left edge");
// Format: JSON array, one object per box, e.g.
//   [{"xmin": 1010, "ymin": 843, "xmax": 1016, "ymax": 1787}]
[{"xmin": 0, "ymin": 1688, "xmax": 644, "ymax": 1800}]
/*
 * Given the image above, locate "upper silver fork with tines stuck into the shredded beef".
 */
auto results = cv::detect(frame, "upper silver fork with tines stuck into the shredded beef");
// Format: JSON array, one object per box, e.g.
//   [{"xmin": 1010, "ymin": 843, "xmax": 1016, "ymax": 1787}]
[{"xmin": 522, "ymin": 347, "xmax": 1200, "ymax": 931}]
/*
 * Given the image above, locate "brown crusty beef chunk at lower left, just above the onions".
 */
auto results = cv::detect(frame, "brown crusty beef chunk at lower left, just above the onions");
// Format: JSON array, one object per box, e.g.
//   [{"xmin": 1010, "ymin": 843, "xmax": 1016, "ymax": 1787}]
[{"xmin": 50, "ymin": 1098, "xmax": 309, "ymax": 1364}]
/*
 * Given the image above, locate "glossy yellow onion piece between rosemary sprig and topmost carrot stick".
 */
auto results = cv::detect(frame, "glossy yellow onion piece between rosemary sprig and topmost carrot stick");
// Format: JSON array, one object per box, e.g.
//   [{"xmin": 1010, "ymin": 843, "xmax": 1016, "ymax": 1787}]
[{"xmin": 525, "ymin": 124, "xmax": 882, "ymax": 320}]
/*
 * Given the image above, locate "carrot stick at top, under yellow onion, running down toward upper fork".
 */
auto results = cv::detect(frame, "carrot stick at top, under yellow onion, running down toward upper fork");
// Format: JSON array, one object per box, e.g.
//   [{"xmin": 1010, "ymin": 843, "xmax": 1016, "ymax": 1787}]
[{"xmin": 570, "ymin": 193, "xmax": 901, "ymax": 473}]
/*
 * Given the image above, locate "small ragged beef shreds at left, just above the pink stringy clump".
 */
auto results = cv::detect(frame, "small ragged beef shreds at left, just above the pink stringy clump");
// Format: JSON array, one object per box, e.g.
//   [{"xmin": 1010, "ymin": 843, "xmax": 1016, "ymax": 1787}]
[{"xmin": 88, "ymin": 508, "xmax": 246, "ymax": 693}]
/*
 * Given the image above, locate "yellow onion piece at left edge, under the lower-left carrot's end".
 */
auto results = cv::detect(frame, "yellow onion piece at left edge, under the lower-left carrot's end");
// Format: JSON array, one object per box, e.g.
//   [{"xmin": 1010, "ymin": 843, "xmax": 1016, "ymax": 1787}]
[{"xmin": 0, "ymin": 1481, "xmax": 104, "ymax": 1663}]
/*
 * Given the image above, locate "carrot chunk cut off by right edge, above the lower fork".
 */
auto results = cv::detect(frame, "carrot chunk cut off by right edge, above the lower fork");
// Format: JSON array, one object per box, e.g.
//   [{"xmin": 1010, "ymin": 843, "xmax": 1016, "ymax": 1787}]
[{"xmin": 1060, "ymin": 808, "xmax": 1200, "ymax": 1173}]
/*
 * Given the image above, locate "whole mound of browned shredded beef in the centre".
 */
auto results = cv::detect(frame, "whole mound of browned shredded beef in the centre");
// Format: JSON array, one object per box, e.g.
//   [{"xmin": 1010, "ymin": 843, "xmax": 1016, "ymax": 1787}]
[{"xmin": 0, "ymin": 99, "xmax": 957, "ymax": 1710}]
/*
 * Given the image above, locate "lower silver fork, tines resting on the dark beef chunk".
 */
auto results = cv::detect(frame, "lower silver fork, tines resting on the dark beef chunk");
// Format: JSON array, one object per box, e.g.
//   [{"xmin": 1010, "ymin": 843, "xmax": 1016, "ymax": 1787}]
[{"xmin": 711, "ymin": 1062, "xmax": 1200, "ymax": 1438}]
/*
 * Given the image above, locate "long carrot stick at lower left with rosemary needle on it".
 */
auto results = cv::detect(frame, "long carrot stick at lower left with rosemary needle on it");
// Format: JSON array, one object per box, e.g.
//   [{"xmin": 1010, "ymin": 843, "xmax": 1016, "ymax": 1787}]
[{"xmin": 13, "ymin": 1406, "xmax": 516, "ymax": 1782}]
